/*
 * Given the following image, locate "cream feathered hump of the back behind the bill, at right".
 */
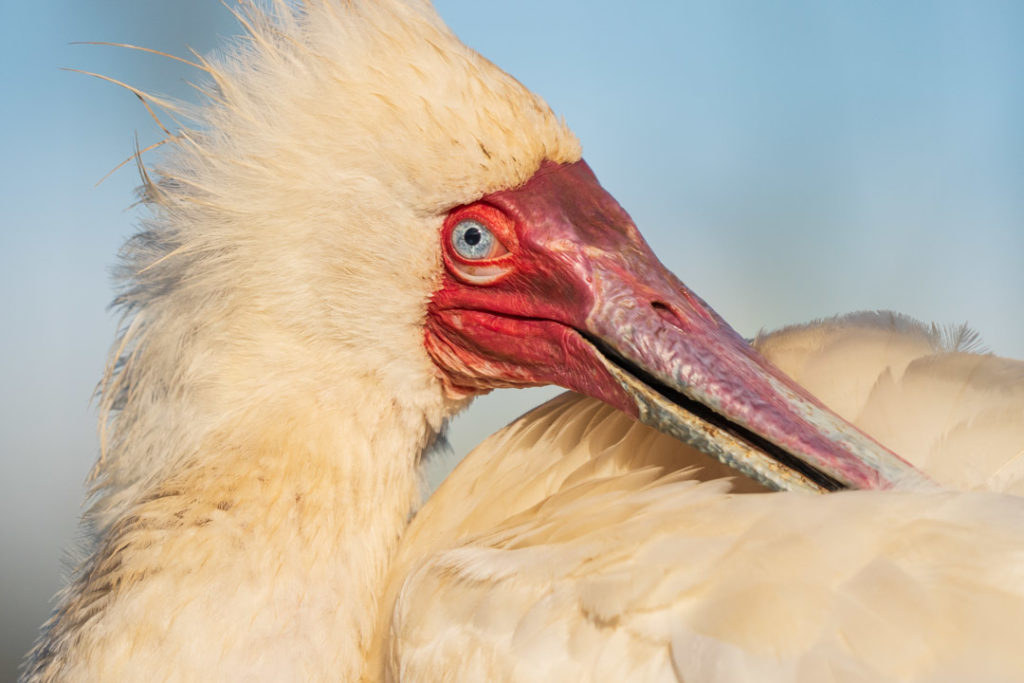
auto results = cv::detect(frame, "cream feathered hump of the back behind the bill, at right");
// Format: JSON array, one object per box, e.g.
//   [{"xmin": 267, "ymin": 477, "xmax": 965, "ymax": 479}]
[{"xmin": 755, "ymin": 312, "xmax": 1024, "ymax": 495}]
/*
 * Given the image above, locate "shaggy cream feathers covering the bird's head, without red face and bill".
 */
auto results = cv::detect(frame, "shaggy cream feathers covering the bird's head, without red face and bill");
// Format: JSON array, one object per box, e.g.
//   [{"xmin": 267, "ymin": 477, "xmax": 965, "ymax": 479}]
[{"xmin": 96, "ymin": 0, "xmax": 580, "ymax": 528}]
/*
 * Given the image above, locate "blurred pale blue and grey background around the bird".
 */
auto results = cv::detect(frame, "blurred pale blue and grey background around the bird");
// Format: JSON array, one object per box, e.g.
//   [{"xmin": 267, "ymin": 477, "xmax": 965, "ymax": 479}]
[{"xmin": 0, "ymin": 0, "xmax": 1024, "ymax": 679}]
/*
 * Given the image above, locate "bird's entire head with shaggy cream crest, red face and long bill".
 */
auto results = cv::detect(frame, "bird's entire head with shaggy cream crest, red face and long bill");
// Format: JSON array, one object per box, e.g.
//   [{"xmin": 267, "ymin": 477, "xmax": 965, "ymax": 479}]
[{"xmin": 123, "ymin": 0, "xmax": 925, "ymax": 488}]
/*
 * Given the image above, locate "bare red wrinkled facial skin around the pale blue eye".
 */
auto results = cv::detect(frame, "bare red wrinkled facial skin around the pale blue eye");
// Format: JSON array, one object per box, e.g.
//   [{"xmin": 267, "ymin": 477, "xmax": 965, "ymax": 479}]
[{"xmin": 425, "ymin": 162, "xmax": 639, "ymax": 415}]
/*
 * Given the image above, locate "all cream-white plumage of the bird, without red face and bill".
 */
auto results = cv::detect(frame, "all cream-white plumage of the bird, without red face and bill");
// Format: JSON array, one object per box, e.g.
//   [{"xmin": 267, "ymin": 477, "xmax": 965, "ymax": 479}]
[{"xmin": 25, "ymin": 0, "xmax": 1024, "ymax": 681}]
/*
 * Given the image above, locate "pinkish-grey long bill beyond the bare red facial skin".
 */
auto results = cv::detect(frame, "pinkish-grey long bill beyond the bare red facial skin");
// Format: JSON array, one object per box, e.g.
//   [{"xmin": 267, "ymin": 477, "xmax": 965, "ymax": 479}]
[{"xmin": 588, "ymin": 284, "xmax": 923, "ymax": 492}]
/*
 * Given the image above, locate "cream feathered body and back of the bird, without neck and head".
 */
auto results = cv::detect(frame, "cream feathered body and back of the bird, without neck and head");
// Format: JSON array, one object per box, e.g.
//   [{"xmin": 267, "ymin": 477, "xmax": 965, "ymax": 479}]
[{"xmin": 377, "ymin": 313, "xmax": 1024, "ymax": 682}]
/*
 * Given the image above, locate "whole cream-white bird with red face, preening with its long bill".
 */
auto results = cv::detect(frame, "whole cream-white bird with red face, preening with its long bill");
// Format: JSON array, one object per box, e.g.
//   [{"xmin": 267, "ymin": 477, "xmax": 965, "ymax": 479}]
[{"xmin": 23, "ymin": 0, "xmax": 1024, "ymax": 681}]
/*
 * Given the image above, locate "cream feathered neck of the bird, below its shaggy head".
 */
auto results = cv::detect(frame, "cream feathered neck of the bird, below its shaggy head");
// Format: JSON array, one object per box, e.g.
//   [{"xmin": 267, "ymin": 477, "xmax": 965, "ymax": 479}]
[{"xmin": 61, "ymin": 325, "xmax": 454, "ymax": 680}]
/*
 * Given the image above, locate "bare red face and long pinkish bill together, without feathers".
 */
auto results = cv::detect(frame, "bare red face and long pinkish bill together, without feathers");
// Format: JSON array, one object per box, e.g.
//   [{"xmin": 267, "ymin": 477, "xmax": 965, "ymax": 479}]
[{"xmin": 427, "ymin": 161, "xmax": 927, "ymax": 492}]
